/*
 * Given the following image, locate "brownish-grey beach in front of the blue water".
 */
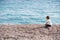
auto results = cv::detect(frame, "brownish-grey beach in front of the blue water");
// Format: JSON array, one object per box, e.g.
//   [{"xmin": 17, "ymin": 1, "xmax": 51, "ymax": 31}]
[{"xmin": 0, "ymin": 24, "xmax": 60, "ymax": 40}]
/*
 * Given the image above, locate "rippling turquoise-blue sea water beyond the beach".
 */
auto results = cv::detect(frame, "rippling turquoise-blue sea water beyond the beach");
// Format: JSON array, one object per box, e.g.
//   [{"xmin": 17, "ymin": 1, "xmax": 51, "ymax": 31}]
[{"xmin": 0, "ymin": 0, "xmax": 60, "ymax": 24}]
